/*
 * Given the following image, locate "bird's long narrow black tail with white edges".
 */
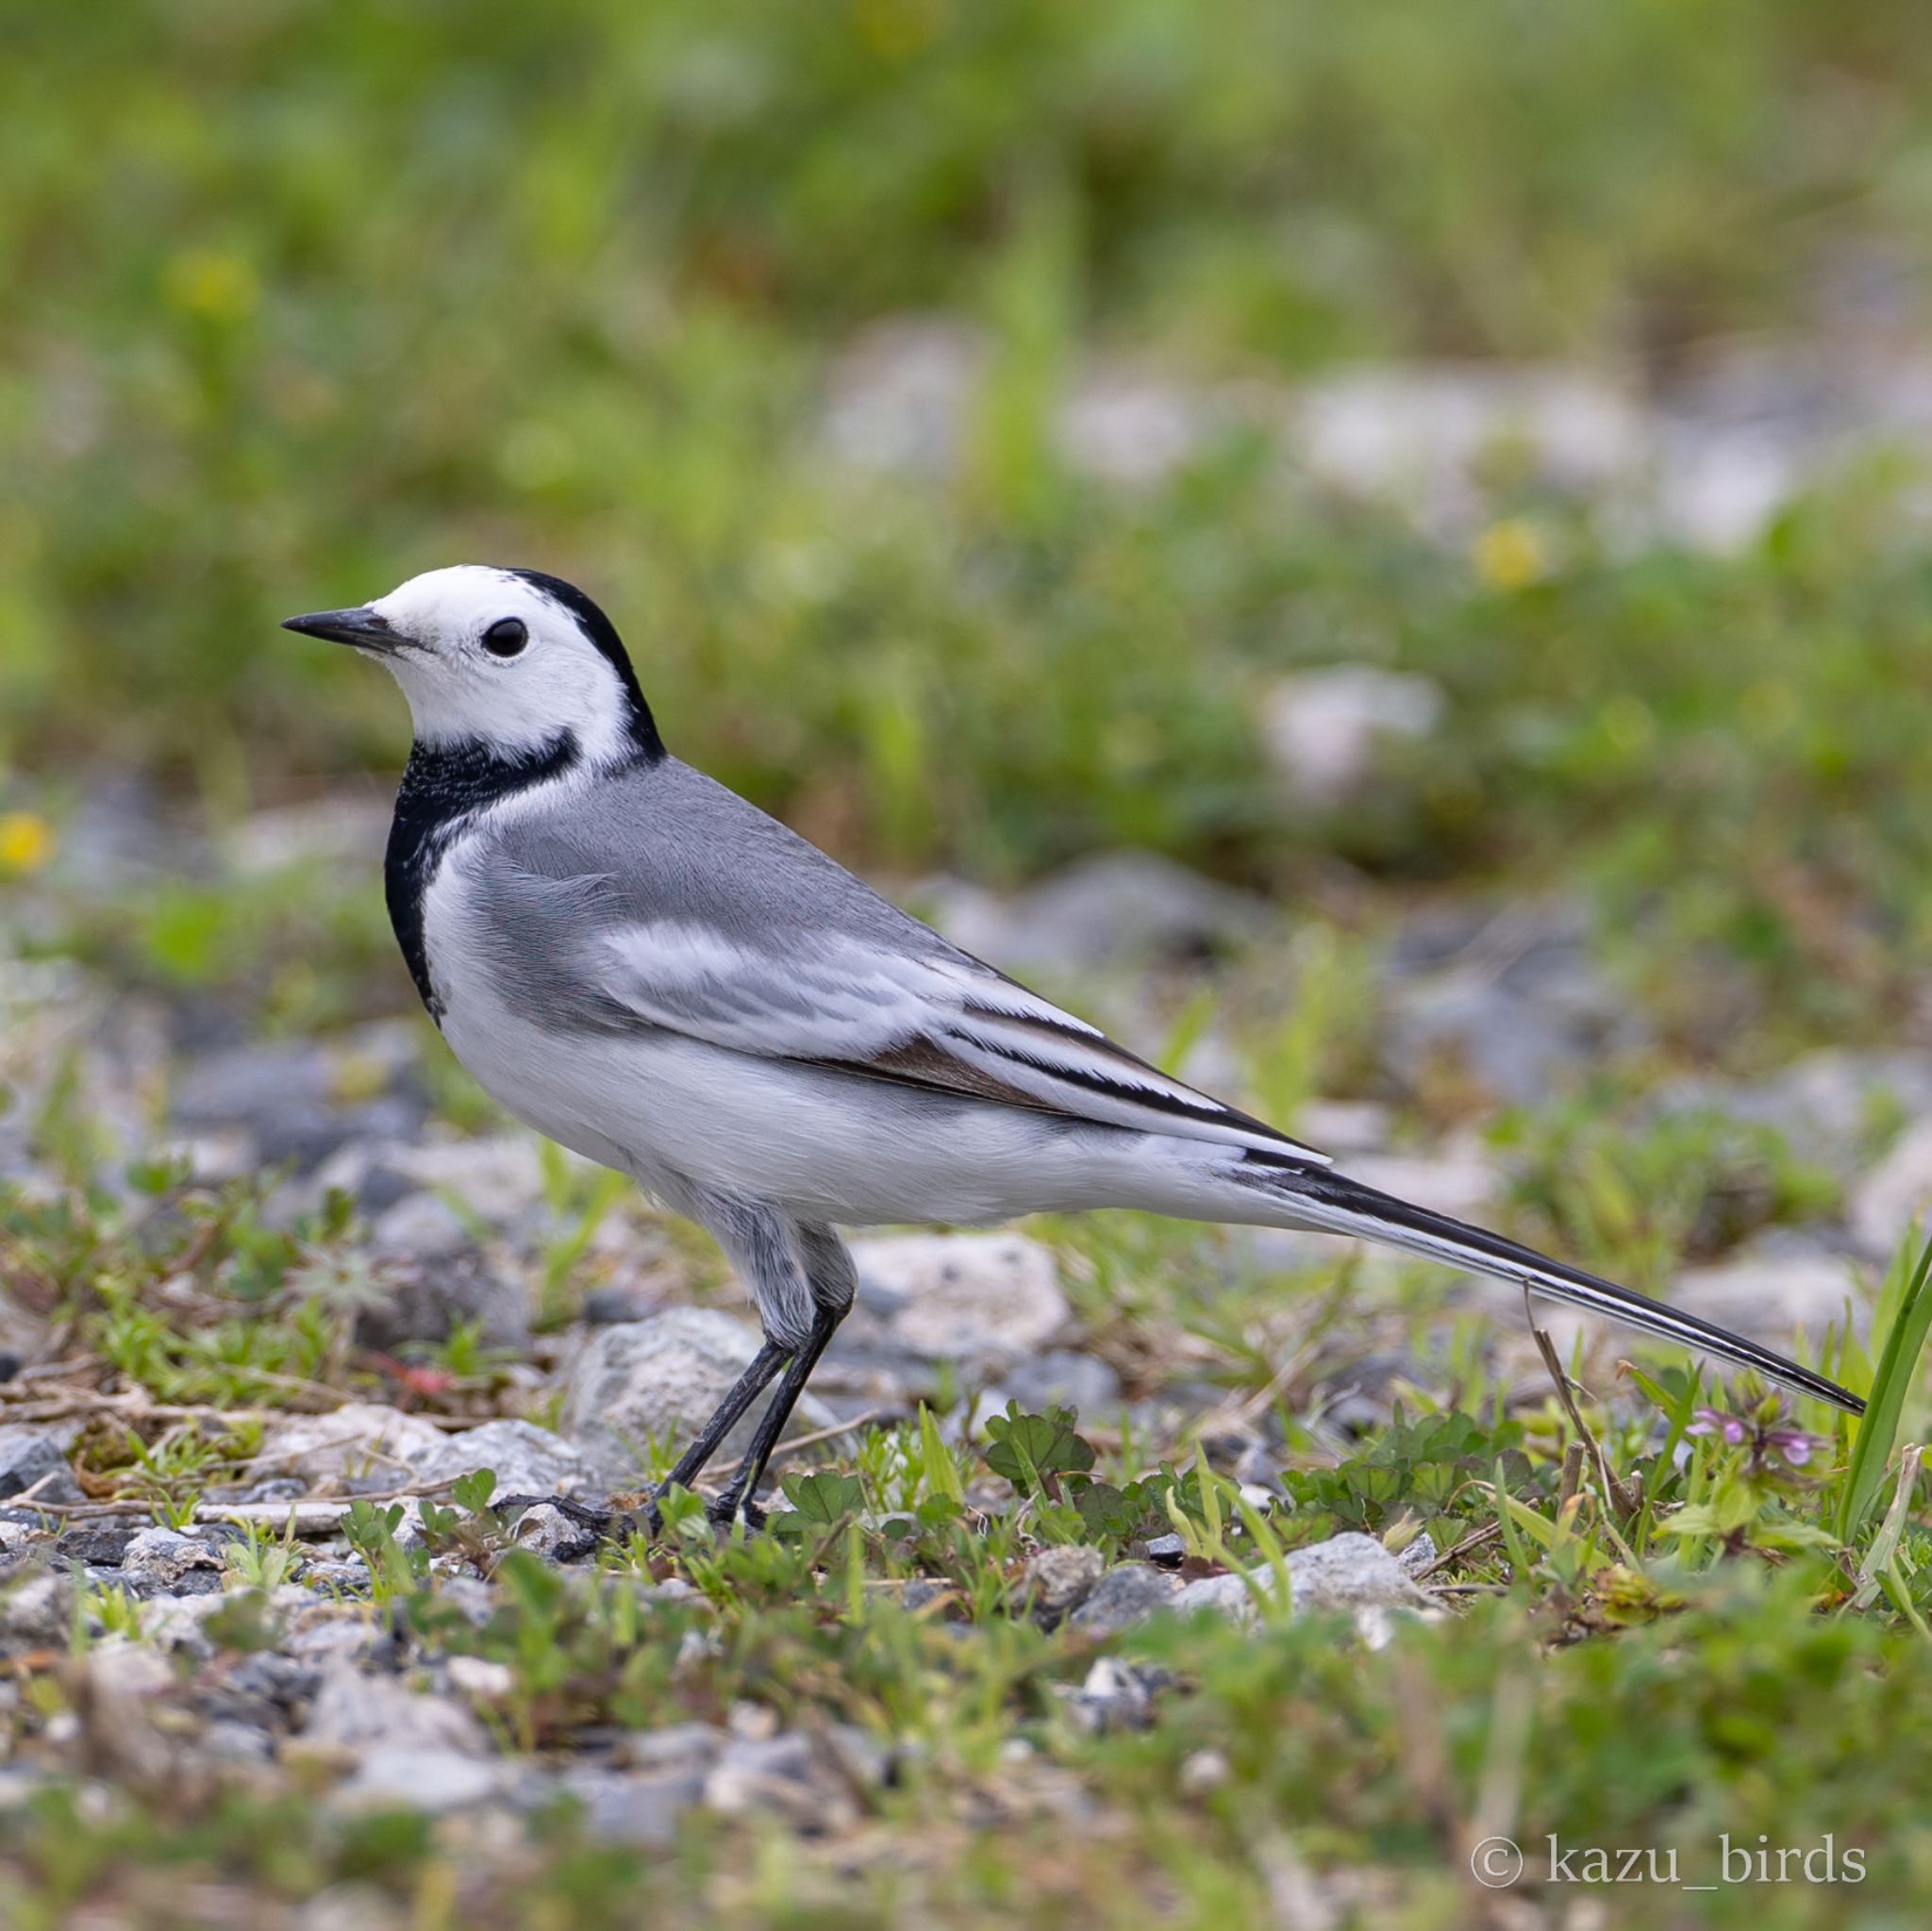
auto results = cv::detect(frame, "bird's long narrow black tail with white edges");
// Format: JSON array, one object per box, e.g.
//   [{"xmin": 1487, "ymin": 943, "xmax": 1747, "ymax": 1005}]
[{"xmin": 1239, "ymin": 1153, "xmax": 1864, "ymax": 1415}]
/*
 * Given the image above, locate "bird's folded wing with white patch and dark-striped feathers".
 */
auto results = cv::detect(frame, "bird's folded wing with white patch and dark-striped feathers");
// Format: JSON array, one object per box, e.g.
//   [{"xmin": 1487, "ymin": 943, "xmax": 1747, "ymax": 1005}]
[{"xmin": 593, "ymin": 919, "xmax": 1327, "ymax": 1164}]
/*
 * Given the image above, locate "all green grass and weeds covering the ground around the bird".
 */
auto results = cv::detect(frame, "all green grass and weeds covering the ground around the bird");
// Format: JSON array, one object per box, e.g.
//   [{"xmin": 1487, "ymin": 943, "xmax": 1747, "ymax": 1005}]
[{"xmin": 11, "ymin": 0, "xmax": 1932, "ymax": 1931}]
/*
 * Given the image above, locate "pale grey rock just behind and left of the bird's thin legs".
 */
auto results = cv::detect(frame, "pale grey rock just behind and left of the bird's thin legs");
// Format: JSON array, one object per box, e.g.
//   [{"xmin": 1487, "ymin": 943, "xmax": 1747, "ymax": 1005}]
[{"xmin": 560, "ymin": 1307, "xmax": 831, "ymax": 1487}]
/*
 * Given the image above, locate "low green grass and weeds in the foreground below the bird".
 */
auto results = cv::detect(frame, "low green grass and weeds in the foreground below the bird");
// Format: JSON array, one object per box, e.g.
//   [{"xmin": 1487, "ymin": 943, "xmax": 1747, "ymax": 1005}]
[{"xmin": 0, "ymin": 1135, "xmax": 1932, "ymax": 1927}]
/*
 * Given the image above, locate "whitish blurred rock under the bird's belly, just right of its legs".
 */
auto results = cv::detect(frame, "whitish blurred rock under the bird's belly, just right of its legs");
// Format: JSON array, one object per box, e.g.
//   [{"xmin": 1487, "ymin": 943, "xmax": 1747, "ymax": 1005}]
[{"xmin": 852, "ymin": 1234, "xmax": 1069, "ymax": 1361}]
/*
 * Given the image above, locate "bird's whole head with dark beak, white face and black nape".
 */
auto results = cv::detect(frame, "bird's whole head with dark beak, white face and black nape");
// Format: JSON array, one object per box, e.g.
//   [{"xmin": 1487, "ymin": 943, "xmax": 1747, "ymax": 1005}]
[{"xmin": 282, "ymin": 564, "xmax": 662, "ymax": 763}]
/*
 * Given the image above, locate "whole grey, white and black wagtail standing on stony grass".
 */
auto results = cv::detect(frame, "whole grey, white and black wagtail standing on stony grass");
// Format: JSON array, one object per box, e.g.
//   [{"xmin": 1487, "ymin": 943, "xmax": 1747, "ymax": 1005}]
[{"xmin": 284, "ymin": 564, "xmax": 1862, "ymax": 1525}]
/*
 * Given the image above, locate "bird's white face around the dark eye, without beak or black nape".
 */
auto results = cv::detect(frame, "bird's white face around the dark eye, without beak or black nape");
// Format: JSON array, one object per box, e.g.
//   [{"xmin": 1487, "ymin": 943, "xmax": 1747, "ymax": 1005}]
[{"xmin": 367, "ymin": 564, "xmax": 630, "ymax": 758}]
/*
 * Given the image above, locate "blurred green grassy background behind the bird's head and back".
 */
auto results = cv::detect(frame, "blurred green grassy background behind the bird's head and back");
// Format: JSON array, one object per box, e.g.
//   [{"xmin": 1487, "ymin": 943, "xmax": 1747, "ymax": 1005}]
[{"xmin": 0, "ymin": 0, "xmax": 1932, "ymax": 1037}]
